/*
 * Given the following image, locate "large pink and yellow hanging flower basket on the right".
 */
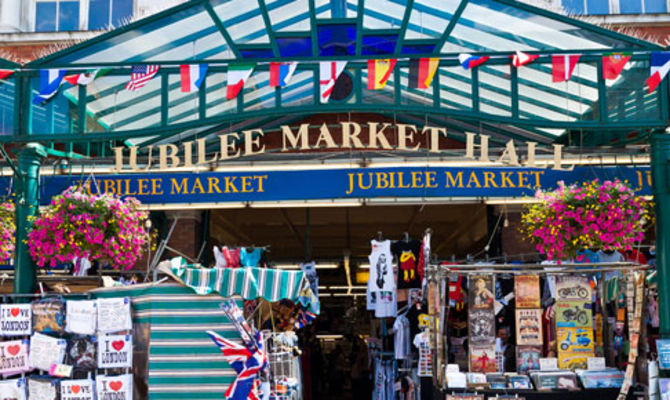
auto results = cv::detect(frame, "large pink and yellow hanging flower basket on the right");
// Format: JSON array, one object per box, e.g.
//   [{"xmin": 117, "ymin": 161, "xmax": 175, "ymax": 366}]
[{"xmin": 521, "ymin": 180, "xmax": 651, "ymax": 260}]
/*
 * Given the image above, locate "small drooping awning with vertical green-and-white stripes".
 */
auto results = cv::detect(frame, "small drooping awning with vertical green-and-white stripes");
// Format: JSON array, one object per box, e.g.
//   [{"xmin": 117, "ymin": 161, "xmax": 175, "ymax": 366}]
[{"xmin": 171, "ymin": 265, "xmax": 320, "ymax": 314}]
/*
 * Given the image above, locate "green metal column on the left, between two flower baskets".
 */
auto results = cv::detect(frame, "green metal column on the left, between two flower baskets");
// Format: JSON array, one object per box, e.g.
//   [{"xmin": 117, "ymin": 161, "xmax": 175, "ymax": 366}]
[{"xmin": 14, "ymin": 143, "xmax": 46, "ymax": 293}]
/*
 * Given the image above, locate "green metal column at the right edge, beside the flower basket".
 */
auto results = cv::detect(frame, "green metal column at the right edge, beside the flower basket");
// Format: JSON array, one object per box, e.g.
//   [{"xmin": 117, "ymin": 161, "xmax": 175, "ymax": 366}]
[{"xmin": 651, "ymin": 133, "xmax": 670, "ymax": 338}]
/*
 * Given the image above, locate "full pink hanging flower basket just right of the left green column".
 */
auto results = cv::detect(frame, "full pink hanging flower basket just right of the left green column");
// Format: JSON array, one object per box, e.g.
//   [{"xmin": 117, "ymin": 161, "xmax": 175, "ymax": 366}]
[{"xmin": 28, "ymin": 186, "xmax": 151, "ymax": 269}]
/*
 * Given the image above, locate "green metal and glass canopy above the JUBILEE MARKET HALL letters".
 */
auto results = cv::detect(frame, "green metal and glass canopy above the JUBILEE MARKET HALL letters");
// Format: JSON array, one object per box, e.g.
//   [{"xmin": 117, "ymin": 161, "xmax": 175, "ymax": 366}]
[{"xmin": 11, "ymin": 0, "xmax": 668, "ymax": 148}]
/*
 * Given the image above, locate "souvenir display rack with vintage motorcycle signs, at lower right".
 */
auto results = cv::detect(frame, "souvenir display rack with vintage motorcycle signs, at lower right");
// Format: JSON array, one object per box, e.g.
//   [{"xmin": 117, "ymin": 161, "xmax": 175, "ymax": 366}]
[{"xmin": 426, "ymin": 262, "xmax": 652, "ymax": 400}]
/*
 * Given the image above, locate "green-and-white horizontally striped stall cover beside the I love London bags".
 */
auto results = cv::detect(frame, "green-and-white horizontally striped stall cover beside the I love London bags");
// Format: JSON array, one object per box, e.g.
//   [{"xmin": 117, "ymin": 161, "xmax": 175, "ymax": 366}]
[{"xmin": 93, "ymin": 284, "xmax": 242, "ymax": 400}]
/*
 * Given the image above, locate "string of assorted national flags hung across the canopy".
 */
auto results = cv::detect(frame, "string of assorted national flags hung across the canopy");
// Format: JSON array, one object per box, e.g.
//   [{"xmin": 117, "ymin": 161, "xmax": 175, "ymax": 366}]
[{"xmin": 17, "ymin": 51, "xmax": 670, "ymax": 104}]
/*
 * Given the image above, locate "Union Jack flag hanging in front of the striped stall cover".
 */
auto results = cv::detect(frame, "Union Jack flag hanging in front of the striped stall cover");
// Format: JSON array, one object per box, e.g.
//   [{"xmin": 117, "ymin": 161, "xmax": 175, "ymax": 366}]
[{"xmin": 207, "ymin": 331, "xmax": 267, "ymax": 400}]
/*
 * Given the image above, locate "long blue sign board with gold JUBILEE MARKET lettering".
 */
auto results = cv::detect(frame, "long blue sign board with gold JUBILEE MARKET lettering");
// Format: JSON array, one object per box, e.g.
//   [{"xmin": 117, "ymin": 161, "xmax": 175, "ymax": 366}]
[{"xmin": 0, "ymin": 166, "xmax": 651, "ymax": 204}]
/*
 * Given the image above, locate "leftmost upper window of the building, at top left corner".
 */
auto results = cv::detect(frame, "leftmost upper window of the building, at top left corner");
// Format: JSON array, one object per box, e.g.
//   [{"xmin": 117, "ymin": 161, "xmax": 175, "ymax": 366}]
[{"xmin": 35, "ymin": 0, "xmax": 79, "ymax": 32}]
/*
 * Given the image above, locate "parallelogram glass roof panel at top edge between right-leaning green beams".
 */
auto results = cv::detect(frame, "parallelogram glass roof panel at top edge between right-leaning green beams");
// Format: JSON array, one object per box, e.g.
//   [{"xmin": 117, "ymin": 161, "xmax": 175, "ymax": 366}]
[{"xmin": 405, "ymin": 0, "xmax": 461, "ymax": 39}]
